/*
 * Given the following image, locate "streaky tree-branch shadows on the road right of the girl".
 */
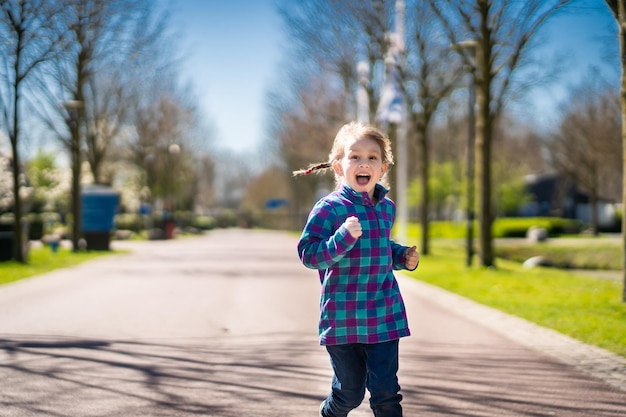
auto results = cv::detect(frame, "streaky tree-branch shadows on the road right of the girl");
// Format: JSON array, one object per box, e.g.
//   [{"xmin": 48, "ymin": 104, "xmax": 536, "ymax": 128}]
[{"xmin": 400, "ymin": 341, "xmax": 626, "ymax": 417}]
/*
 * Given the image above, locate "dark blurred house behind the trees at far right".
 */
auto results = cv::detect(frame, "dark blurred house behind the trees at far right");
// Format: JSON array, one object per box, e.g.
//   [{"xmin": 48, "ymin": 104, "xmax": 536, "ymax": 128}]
[{"xmin": 519, "ymin": 174, "xmax": 618, "ymax": 229}]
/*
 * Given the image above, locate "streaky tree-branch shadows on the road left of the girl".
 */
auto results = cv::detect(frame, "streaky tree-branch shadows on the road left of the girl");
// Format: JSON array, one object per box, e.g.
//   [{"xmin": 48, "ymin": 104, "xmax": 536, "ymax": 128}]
[{"xmin": 0, "ymin": 334, "xmax": 328, "ymax": 417}]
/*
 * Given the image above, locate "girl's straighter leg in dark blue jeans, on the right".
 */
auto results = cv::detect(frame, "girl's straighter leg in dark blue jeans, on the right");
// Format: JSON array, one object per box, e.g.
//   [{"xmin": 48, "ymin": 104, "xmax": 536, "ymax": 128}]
[{"xmin": 366, "ymin": 340, "xmax": 402, "ymax": 417}]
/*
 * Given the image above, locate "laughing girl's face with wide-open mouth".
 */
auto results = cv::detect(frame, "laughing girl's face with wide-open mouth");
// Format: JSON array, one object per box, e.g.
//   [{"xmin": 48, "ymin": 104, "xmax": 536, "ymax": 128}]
[{"xmin": 333, "ymin": 134, "xmax": 387, "ymax": 199}]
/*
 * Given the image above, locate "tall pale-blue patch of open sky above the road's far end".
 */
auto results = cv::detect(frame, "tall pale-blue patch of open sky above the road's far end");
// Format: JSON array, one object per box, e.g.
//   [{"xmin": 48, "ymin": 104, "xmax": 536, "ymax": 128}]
[{"xmin": 171, "ymin": 0, "xmax": 282, "ymax": 152}]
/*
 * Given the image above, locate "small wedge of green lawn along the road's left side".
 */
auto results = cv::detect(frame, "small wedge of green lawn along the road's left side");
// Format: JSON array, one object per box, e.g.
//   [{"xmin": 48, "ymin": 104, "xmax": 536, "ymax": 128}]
[{"xmin": 0, "ymin": 247, "xmax": 115, "ymax": 285}]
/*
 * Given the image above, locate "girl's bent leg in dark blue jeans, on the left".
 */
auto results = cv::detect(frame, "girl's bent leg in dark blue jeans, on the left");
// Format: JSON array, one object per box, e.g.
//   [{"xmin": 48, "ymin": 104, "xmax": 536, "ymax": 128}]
[{"xmin": 320, "ymin": 344, "xmax": 367, "ymax": 417}]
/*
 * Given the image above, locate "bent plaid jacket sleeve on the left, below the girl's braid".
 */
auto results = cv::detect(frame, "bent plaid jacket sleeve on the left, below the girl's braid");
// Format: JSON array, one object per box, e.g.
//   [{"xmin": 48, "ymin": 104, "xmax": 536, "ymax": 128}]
[{"xmin": 298, "ymin": 200, "xmax": 357, "ymax": 269}]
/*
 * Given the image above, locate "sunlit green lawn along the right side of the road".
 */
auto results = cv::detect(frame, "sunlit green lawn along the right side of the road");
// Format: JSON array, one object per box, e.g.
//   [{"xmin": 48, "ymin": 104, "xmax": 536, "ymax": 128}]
[{"xmin": 410, "ymin": 239, "xmax": 626, "ymax": 357}]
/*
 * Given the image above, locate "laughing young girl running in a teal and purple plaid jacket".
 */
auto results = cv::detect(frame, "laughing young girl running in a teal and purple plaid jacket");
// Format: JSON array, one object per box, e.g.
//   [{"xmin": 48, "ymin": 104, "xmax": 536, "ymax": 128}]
[{"xmin": 294, "ymin": 122, "xmax": 419, "ymax": 417}]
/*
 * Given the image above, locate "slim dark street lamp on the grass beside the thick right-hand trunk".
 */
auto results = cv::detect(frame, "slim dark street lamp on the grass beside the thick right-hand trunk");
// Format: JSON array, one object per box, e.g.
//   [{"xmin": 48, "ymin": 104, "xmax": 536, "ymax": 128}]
[{"xmin": 452, "ymin": 40, "xmax": 478, "ymax": 267}]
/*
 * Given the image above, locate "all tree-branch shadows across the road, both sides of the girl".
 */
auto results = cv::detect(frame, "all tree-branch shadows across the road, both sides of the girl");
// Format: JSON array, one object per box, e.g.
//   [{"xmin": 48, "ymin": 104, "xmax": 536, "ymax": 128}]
[{"xmin": 0, "ymin": 334, "xmax": 625, "ymax": 417}]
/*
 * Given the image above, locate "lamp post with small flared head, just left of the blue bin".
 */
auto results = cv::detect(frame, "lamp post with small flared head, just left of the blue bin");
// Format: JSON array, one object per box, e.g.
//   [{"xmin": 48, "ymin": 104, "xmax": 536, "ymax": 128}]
[{"xmin": 64, "ymin": 100, "xmax": 83, "ymax": 252}]
